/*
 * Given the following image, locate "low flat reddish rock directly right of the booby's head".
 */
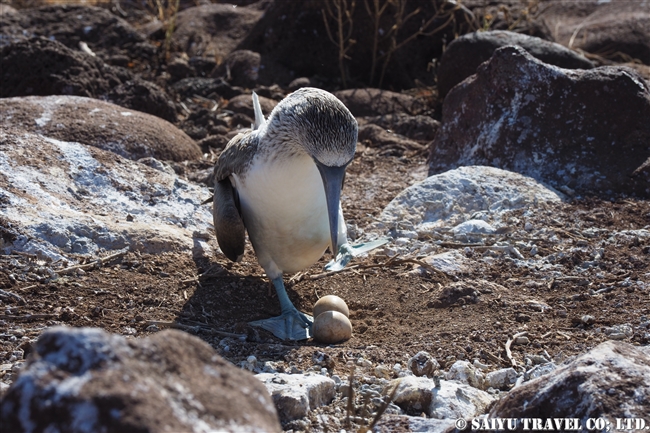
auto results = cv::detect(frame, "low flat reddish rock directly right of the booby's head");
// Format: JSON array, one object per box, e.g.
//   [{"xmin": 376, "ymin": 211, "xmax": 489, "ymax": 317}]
[{"xmin": 334, "ymin": 88, "xmax": 423, "ymax": 117}]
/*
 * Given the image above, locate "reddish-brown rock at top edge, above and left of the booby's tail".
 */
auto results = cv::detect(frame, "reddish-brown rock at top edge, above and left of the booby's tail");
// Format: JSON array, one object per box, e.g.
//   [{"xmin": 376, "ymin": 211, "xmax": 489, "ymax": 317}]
[{"xmin": 172, "ymin": 3, "xmax": 262, "ymax": 59}]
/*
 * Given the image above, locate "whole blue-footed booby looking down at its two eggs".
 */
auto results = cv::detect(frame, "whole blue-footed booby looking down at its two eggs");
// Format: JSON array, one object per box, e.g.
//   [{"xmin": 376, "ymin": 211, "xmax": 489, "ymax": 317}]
[{"xmin": 214, "ymin": 87, "xmax": 377, "ymax": 340}]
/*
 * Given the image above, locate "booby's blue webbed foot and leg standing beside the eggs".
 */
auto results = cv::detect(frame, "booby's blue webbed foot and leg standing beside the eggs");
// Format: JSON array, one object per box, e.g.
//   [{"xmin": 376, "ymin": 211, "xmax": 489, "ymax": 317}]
[{"xmin": 249, "ymin": 277, "xmax": 314, "ymax": 340}]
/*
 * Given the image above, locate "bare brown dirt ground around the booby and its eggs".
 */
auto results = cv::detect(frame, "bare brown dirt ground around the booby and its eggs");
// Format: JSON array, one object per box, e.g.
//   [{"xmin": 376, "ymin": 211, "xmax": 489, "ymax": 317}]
[{"xmin": 0, "ymin": 146, "xmax": 650, "ymax": 390}]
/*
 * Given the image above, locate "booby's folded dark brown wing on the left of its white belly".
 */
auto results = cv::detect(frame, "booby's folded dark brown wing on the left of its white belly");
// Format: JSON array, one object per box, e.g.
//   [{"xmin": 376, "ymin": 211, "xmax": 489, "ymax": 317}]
[{"xmin": 212, "ymin": 131, "xmax": 258, "ymax": 262}]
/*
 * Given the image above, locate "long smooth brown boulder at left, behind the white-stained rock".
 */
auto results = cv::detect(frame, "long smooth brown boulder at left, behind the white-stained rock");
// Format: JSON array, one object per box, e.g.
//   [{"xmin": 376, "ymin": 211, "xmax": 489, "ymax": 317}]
[{"xmin": 0, "ymin": 95, "xmax": 201, "ymax": 161}]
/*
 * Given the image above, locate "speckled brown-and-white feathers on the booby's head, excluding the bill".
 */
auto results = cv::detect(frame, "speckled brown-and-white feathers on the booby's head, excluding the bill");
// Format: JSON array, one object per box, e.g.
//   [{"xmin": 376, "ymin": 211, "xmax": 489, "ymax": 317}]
[{"xmin": 266, "ymin": 87, "xmax": 358, "ymax": 167}]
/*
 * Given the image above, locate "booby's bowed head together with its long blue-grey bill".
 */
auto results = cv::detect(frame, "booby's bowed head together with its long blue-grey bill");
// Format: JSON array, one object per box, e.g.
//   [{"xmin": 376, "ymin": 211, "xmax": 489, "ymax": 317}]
[{"xmin": 268, "ymin": 87, "xmax": 358, "ymax": 255}]
